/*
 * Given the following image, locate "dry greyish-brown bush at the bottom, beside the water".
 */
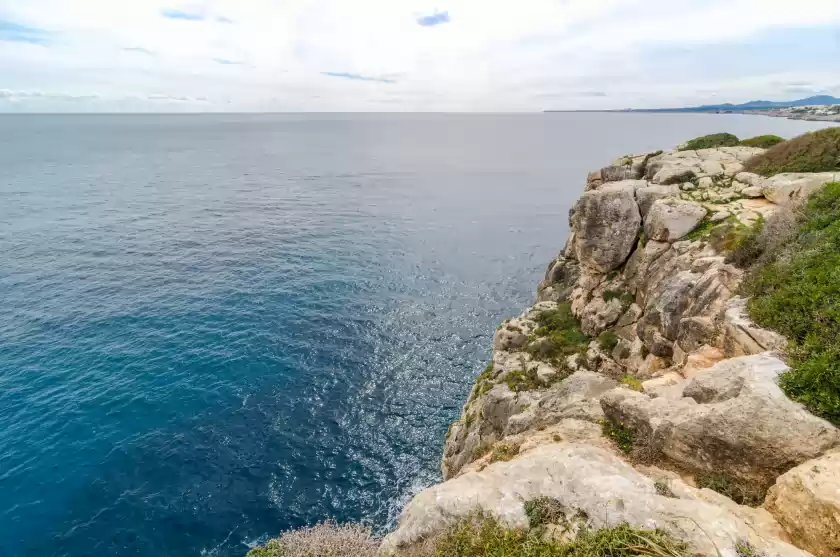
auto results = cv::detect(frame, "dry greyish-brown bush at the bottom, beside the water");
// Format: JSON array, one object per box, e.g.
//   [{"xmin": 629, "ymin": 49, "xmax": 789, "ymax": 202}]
[{"xmin": 248, "ymin": 520, "xmax": 381, "ymax": 557}]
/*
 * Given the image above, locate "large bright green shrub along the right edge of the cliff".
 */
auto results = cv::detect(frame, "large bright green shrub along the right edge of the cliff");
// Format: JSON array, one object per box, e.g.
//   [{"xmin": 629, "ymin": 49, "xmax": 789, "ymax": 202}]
[{"xmin": 743, "ymin": 183, "xmax": 840, "ymax": 425}]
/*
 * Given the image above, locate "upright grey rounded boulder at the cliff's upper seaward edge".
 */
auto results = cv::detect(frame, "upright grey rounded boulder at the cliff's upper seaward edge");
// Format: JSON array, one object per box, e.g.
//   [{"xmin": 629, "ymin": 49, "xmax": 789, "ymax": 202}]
[{"xmin": 571, "ymin": 187, "xmax": 642, "ymax": 273}]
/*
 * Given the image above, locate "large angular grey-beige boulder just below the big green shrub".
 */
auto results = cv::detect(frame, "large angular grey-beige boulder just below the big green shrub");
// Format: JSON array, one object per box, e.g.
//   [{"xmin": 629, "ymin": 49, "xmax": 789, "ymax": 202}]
[{"xmin": 601, "ymin": 354, "xmax": 840, "ymax": 484}]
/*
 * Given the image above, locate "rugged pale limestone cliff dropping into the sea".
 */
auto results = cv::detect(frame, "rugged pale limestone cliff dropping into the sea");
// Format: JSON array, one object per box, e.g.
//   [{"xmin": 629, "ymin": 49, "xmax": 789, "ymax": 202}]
[{"xmin": 383, "ymin": 147, "xmax": 840, "ymax": 556}]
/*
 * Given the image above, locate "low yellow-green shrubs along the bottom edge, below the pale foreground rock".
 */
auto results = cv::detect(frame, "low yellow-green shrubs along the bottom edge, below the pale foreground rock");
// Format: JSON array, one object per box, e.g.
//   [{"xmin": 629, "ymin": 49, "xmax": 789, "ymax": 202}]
[{"xmin": 426, "ymin": 514, "xmax": 690, "ymax": 557}]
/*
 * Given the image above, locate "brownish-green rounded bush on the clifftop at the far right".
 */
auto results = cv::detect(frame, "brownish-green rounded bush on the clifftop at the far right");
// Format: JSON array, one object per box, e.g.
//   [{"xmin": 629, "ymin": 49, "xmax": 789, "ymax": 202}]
[{"xmin": 744, "ymin": 128, "xmax": 840, "ymax": 176}]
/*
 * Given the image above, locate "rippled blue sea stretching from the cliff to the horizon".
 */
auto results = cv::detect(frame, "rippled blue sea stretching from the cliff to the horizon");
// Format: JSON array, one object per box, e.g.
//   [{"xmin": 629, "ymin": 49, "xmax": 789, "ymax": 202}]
[{"xmin": 0, "ymin": 113, "xmax": 822, "ymax": 557}]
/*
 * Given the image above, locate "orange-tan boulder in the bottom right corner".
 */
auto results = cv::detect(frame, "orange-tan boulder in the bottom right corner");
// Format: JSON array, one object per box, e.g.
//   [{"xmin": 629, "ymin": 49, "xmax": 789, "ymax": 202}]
[{"xmin": 764, "ymin": 452, "xmax": 840, "ymax": 557}]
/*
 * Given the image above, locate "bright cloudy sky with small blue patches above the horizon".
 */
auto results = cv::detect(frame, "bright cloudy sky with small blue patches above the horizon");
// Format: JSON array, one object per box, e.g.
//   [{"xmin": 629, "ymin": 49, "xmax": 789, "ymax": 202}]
[{"xmin": 0, "ymin": 0, "xmax": 840, "ymax": 112}]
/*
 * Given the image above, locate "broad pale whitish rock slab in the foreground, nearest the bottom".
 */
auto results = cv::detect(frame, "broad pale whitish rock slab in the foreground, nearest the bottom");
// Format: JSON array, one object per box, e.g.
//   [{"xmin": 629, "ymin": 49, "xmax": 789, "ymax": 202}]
[{"xmin": 381, "ymin": 442, "xmax": 807, "ymax": 557}]
